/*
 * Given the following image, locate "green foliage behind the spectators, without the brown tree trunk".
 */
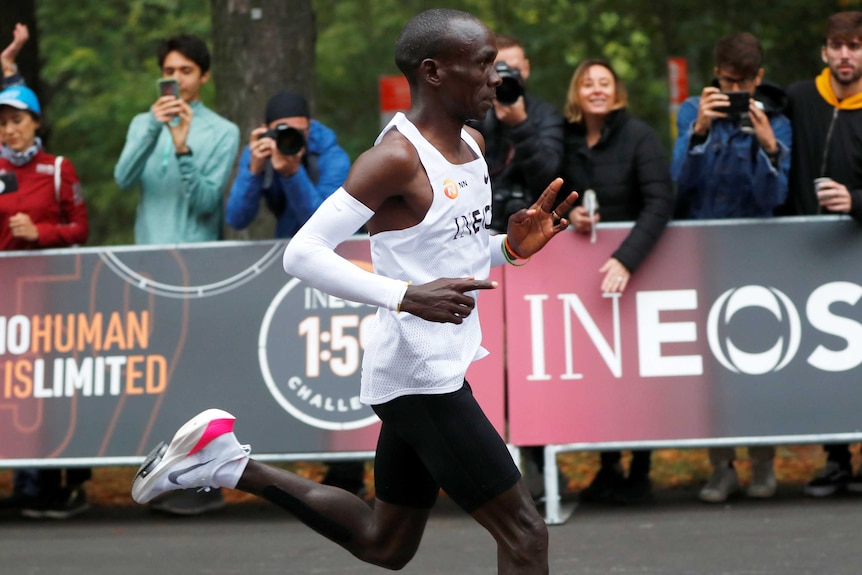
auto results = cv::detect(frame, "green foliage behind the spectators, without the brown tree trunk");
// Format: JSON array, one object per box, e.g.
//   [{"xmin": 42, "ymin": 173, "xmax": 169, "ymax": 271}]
[{"xmin": 30, "ymin": 0, "xmax": 862, "ymax": 245}]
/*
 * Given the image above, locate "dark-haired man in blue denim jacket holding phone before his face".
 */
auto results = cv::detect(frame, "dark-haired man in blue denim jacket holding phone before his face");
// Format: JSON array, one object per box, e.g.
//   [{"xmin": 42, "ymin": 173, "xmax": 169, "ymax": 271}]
[{"xmin": 671, "ymin": 32, "xmax": 793, "ymax": 503}]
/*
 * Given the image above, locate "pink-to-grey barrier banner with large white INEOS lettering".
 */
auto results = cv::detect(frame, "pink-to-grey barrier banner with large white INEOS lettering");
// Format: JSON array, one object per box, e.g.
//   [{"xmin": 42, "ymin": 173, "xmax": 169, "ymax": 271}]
[{"xmin": 505, "ymin": 218, "xmax": 862, "ymax": 445}]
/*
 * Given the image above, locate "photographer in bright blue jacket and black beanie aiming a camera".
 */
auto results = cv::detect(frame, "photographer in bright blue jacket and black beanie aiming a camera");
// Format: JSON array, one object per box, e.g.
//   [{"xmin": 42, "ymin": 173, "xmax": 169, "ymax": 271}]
[{"xmin": 227, "ymin": 92, "xmax": 350, "ymax": 238}]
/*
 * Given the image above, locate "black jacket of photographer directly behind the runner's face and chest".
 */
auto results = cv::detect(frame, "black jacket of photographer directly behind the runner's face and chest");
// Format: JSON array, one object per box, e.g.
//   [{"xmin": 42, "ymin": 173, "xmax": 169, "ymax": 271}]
[{"xmin": 472, "ymin": 94, "xmax": 563, "ymax": 232}]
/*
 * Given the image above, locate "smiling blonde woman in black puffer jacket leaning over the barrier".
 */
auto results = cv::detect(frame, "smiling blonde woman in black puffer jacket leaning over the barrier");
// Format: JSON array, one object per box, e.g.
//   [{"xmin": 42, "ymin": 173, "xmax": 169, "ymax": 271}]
[{"xmin": 561, "ymin": 59, "xmax": 673, "ymax": 503}]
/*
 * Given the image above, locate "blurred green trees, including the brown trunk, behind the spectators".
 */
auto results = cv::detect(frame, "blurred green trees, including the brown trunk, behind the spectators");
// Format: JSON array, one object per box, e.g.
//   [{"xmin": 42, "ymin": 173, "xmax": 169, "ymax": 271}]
[{"xmin": 5, "ymin": 0, "xmax": 862, "ymax": 245}]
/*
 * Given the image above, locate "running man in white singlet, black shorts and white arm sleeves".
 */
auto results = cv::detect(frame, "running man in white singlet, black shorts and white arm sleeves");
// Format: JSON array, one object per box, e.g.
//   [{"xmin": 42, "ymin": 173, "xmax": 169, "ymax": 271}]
[{"xmin": 132, "ymin": 10, "xmax": 577, "ymax": 575}]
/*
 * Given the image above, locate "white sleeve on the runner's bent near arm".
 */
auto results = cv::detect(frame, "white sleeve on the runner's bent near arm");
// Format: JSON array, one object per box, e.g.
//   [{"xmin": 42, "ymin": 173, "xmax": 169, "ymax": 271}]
[{"xmin": 282, "ymin": 188, "xmax": 408, "ymax": 311}]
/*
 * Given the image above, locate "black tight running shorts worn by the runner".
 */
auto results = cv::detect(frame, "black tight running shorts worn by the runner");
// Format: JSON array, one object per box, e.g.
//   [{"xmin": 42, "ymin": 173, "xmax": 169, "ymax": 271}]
[{"xmin": 372, "ymin": 381, "xmax": 521, "ymax": 513}]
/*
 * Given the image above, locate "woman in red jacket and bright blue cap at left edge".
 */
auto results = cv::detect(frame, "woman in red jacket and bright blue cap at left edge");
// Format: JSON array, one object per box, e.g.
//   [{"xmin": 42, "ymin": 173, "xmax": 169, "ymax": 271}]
[{"xmin": 0, "ymin": 86, "xmax": 89, "ymax": 251}]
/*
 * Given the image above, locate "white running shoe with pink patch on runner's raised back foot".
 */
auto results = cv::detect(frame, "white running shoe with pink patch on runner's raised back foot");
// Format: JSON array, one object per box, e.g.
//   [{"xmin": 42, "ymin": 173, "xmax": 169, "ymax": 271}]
[{"xmin": 132, "ymin": 409, "xmax": 251, "ymax": 503}]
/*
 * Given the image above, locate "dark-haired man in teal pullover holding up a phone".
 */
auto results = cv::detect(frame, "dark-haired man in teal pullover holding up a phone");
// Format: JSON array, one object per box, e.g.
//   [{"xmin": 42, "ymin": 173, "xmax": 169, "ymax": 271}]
[{"xmin": 114, "ymin": 35, "xmax": 239, "ymax": 244}]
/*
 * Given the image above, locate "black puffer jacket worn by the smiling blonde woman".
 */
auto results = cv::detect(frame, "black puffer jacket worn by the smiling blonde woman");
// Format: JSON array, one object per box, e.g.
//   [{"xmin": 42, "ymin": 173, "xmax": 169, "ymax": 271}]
[{"xmin": 562, "ymin": 109, "xmax": 674, "ymax": 272}]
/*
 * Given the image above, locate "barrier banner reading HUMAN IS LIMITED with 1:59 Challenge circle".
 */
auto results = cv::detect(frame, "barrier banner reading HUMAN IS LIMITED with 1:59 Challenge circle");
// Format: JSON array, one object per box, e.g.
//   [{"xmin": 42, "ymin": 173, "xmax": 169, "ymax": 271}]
[{"xmin": 0, "ymin": 239, "xmax": 505, "ymax": 467}]
